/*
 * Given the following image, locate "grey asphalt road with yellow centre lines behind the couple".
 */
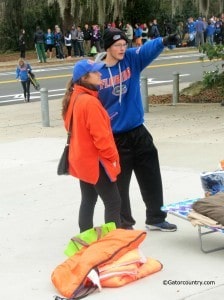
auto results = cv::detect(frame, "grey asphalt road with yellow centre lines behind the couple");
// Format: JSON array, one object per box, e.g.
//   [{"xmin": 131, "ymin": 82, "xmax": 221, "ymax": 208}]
[{"xmin": 0, "ymin": 50, "xmax": 221, "ymax": 105}]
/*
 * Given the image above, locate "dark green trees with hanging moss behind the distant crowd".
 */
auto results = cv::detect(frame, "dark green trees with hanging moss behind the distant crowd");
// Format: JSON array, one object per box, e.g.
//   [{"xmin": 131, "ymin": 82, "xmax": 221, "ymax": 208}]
[{"xmin": 0, "ymin": 0, "xmax": 221, "ymax": 52}]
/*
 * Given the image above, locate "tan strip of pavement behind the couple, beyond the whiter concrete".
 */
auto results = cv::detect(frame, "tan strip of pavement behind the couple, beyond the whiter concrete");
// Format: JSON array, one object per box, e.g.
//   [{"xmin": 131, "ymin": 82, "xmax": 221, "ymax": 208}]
[{"xmin": 0, "ymin": 100, "xmax": 224, "ymax": 171}]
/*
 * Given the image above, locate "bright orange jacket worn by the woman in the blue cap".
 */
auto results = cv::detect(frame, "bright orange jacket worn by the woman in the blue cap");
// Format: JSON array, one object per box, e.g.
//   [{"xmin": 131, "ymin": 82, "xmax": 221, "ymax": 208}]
[{"xmin": 64, "ymin": 85, "xmax": 120, "ymax": 184}]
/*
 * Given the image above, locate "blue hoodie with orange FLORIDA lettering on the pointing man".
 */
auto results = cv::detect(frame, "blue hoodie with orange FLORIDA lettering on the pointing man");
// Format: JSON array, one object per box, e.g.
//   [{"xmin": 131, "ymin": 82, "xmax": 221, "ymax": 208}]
[{"xmin": 96, "ymin": 37, "xmax": 164, "ymax": 133}]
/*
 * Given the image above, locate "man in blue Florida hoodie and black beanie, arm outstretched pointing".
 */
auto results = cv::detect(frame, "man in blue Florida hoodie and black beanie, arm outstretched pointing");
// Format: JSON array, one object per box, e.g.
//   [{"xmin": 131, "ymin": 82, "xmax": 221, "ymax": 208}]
[{"xmin": 96, "ymin": 28, "xmax": 177, "ymax": 231}]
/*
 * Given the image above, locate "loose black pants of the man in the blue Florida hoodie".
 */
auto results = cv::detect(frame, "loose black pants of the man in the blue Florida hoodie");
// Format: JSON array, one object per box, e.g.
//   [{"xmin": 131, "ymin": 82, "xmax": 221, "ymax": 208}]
[{"xmin": 114, "ymin": 125, "xmax": 166, "ymax": 228}]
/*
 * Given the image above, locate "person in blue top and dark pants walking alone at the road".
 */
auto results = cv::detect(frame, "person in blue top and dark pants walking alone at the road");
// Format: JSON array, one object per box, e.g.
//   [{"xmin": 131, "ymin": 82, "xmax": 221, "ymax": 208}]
[{"xmin": 16, "ymin": 58, "xmax": 32, "ymax": 102}]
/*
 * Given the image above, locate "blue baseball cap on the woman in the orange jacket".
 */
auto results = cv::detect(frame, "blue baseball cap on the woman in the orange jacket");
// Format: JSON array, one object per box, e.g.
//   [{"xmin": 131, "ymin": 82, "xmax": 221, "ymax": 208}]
[{"xmin": 72, "ymin": 59, "xmax": 105, "ymax": 82}]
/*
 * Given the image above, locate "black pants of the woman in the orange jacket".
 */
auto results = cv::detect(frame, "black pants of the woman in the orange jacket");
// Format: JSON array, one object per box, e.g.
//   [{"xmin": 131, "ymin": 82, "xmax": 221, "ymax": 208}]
[{"xmin": 79, "ymin": 165, "xmax": 121, "ymax": 232}]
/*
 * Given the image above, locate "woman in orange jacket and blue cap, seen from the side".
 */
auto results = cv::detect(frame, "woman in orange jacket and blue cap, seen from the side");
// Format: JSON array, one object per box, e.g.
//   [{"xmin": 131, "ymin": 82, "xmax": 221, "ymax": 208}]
[{"xmin": 62, "ymin": 59, "xmax": 121, "ymax": 232}]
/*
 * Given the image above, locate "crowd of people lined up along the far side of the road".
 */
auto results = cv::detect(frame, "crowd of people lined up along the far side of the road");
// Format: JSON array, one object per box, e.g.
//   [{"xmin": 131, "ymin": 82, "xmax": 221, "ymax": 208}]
[{"xmin": 19, "ymin": 13, "xmax": 224, "ymax": 62}]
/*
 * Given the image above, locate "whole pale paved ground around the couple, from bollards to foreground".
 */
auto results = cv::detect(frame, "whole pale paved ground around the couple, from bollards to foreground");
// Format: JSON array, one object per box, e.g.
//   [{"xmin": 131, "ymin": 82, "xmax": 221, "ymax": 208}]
[{"xmin": 0, "ymin": 48, "xmax": 224, "ymax": 300}]
